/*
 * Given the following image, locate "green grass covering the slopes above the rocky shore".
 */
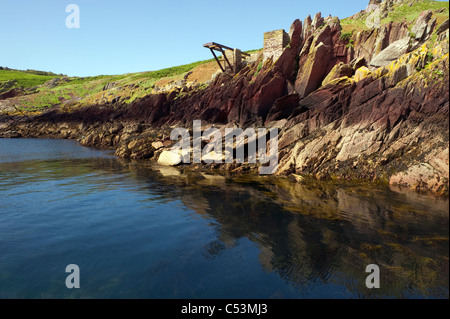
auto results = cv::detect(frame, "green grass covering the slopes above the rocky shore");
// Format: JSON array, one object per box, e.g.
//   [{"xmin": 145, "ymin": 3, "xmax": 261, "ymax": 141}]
[{"xmin": 5, "ymin": 0, "xmax": 449, "ymax": 111}]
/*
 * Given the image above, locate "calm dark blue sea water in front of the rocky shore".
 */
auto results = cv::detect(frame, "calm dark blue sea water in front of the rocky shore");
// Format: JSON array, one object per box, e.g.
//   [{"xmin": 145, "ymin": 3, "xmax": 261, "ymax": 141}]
[{"xmin": 0, "ymin": 139, "xmax": 449, "ymax": 299}]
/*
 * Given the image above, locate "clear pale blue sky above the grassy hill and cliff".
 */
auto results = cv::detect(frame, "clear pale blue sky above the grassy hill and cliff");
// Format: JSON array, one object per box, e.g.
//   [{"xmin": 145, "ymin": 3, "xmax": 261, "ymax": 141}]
[{"xmin": 0, "ymin": 0, "xmax": 369, "ymax": 76}]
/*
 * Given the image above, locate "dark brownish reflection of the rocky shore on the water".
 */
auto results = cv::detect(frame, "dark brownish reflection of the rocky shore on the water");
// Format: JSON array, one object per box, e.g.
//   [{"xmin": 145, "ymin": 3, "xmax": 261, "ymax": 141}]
[{"xmin": 0, "ymin": 139, "xmax": 449, "ymax": 298}]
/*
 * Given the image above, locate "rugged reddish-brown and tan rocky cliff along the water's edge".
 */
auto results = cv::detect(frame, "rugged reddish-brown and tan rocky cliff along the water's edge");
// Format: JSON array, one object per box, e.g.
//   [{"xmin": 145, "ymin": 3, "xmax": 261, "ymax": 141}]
[{"xmin": 0, "ymin": 0, "xmax": 449, "ymax": 195}]
